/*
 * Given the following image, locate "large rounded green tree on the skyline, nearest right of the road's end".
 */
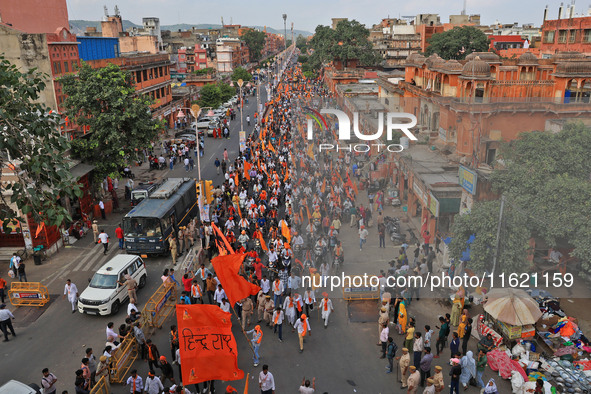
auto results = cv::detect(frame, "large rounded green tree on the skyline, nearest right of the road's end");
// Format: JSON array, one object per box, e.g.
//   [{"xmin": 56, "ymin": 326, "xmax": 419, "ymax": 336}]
[{"xmin": 309, "ymin": 20, "xmax": 381, "ymax": 69}]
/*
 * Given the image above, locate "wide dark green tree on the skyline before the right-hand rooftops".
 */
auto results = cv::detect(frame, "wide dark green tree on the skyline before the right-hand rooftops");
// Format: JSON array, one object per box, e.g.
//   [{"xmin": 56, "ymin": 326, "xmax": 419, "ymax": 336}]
[{"xmin": 425, "ymin": 26, "xmax": 488, "ymax": 60}]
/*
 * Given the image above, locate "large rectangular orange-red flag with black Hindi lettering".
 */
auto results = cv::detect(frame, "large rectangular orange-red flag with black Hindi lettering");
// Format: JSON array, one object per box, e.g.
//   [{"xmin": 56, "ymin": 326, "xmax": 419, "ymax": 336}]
[{"xmin": 176, "ymin": 304, "xmax": 244, "ymax": 385}]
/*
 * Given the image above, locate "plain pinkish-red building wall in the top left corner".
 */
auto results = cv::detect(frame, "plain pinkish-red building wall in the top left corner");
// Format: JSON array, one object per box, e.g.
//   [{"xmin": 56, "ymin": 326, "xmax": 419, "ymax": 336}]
[{"xmin": 0, "ymin": 0, "xmax": 70, "ymax": 33}]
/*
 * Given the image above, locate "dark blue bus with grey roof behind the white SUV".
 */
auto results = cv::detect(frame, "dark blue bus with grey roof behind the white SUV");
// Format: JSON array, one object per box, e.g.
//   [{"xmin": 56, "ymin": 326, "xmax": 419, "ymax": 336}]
[{"xmin": 123, "ymin": 178, "xmax": 199, "ymax": 254}]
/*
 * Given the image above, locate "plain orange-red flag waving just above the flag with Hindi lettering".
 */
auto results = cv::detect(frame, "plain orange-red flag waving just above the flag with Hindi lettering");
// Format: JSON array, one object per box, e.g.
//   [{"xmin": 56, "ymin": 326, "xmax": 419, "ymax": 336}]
[{"xmin": 211, "ymin": 254, "xmax": 261, "ymax": 305}]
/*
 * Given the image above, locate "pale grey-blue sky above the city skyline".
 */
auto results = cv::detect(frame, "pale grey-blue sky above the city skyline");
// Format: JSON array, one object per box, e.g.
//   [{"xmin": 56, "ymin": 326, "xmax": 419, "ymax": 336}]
[{"xmin": 67, "ymin": 0, "xmax": 589, "ymax": 32}]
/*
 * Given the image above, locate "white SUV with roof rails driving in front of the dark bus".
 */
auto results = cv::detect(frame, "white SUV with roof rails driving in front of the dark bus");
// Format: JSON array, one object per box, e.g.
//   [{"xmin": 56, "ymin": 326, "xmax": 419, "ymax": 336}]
[{"xmin": 78, "ymin": 254, "xmax": 147, "ymax": 315}]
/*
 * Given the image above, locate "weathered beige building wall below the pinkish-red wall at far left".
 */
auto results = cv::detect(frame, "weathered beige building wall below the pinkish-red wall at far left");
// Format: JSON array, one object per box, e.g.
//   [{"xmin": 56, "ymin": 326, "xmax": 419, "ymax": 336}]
[{"xmin": 0, "ymin": 25, "xmax": 57, "ymax": 110}]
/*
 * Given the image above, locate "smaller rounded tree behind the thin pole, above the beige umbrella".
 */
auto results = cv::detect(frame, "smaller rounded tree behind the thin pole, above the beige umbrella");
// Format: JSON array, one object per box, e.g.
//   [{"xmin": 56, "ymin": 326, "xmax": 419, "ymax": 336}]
[{"xmin": 450, "ymin": 201, "xmax": 529, "ymax": 273}]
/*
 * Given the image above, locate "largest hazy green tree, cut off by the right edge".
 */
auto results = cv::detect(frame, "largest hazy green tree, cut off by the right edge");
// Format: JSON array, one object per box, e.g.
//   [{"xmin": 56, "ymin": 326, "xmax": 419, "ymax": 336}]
[{"xmin": 492, "ymin": 123, "xmax": 591, "ymax": 273}]
